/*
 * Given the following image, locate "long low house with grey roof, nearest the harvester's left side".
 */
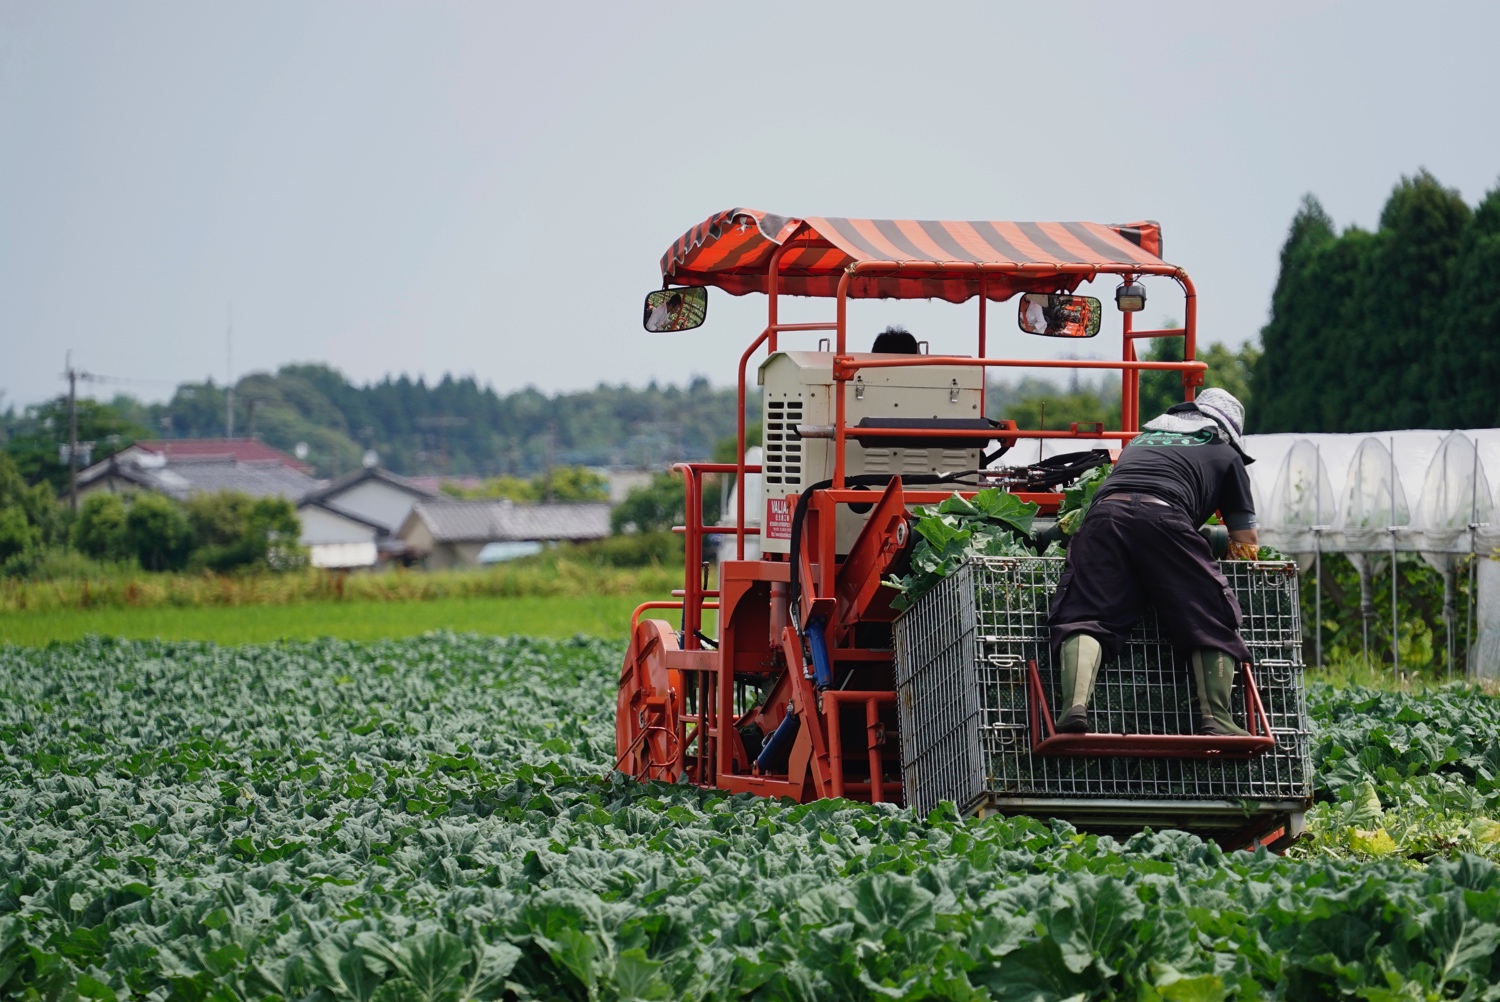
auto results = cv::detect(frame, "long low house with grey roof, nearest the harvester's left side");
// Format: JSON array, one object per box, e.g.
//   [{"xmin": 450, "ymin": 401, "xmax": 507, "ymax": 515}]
[{"xmin": 396, "ymin": 498, "xmax": 611, "ymax": 570}]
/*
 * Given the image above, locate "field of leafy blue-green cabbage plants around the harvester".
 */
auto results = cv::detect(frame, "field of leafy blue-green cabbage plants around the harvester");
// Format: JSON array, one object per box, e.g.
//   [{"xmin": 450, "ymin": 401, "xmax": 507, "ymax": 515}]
[{"xmin": 0, "ymin": 635, "xmax": 1500, "ymax": 1002}]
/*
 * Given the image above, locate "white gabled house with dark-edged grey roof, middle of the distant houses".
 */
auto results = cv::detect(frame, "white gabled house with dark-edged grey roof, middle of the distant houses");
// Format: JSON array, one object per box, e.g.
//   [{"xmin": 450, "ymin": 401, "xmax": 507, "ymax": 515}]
[{"xmin": 297, "ymin": 467, "xmax": 438, "ymax": 567}]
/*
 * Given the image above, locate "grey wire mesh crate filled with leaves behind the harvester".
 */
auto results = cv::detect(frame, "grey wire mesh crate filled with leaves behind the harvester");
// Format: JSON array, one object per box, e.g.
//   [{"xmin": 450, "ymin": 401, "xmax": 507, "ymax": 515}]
[{"xmin": 896, "ymin": 557, "xmax": 1311, "ymax": 812}]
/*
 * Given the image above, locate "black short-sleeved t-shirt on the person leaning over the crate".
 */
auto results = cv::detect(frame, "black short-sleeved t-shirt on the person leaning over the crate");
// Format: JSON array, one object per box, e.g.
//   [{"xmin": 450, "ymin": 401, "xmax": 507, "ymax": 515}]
[{"xmin": 1094, "ymin": 428, "xmax": 1256, "ymax": 525}]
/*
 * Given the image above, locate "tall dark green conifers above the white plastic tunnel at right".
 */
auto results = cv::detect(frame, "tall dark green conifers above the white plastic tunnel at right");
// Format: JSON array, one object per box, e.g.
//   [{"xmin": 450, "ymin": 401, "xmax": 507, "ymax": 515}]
[{"xmin": 1250, "ymin": 171, "xmax": 1500, "ymax": 432}]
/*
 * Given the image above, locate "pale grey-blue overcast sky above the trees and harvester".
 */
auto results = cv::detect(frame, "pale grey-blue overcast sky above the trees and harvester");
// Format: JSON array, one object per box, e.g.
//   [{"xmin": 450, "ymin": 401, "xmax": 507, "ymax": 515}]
[{"xmin": 0, "ymin": 0, "xmax": 1500, "ymax": 410}]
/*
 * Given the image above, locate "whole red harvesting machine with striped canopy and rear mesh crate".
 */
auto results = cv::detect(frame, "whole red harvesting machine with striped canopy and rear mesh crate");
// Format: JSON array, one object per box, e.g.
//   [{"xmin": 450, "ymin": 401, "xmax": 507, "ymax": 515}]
[{"xmin": 617, "ymin": 209, "xmax": 1311, "ymax": 846}]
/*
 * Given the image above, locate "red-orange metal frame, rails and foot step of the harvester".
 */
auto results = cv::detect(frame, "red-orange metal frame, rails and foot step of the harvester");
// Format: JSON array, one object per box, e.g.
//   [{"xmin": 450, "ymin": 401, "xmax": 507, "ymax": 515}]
[{"xmin": 617, "ymin": 234, "xmax": 1272, "ymax": 822}]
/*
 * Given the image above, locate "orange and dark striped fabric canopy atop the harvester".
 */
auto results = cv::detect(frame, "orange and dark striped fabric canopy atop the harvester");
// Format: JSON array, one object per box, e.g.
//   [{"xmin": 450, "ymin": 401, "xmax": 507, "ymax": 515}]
[{"xmin": 662, "ymin": 209, "xmax": 1172, "ymax": 303}]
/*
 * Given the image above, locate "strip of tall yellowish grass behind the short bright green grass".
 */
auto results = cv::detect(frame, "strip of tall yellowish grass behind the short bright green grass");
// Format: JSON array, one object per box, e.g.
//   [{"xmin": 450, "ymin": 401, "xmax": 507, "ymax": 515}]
[{"xmin": 0, "ymin": 558, "xmax": 683, "ymax": 612}]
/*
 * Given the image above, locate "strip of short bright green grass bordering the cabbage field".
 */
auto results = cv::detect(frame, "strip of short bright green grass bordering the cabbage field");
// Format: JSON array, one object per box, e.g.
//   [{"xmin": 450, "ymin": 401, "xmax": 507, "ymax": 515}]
[{"xmin": 0, "ymin": 596, "xmax": 674, "ymax": 647}]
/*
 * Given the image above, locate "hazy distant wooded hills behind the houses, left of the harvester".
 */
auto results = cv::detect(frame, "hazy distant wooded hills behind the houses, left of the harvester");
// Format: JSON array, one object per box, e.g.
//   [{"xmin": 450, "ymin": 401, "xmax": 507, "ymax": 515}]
[{"xmin": 0, "ymin": 365, "xmax": 758, "ymax": 489}]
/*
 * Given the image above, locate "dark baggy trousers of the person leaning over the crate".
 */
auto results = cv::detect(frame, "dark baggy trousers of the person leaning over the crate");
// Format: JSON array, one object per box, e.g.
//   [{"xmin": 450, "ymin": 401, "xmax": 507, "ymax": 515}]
[{"xmin": 1047, "ymin": 498, "xmax": 1250, "ymax": 663}]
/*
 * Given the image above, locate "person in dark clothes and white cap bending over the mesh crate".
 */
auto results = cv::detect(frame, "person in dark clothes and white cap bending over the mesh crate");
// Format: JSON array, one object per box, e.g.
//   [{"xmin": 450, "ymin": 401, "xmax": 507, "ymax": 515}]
[{"xmin": 1049, "ymin": 389, "xmax": 1257, "ymax": 737}]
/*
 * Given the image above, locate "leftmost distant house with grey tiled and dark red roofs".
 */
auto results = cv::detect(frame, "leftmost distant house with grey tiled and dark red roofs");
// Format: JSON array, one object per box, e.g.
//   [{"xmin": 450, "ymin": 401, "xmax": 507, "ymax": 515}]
[{"xmin": 78, "ymin": 438, "xmax": 321, "ymax": 501}]
